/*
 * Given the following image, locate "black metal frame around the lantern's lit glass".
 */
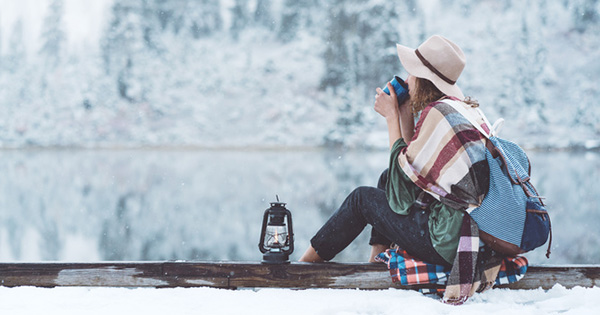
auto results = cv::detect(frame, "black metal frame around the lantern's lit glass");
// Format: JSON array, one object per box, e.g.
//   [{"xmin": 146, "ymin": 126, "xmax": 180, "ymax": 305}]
[{"xmin": 258, "ymin": 197, "xmax": 294, "ymax": 264}]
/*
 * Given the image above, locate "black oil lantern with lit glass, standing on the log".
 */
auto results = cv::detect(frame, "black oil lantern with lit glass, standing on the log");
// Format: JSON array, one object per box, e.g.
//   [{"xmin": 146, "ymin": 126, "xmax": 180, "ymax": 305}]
[{"xmin": 258, "ymin": 196, "xmax": 294, "ymax": 264}]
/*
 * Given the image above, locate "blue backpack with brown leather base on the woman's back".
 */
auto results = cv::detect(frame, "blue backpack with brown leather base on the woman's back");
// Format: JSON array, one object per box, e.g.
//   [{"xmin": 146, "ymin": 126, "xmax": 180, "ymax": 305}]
[{"xmin": 446, "ymin": 100, "xmax": 552, "ymax": 257}]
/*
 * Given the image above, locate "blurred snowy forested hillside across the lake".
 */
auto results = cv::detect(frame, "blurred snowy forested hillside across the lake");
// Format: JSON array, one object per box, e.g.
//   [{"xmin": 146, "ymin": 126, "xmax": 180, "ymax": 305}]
[{"xmin": 0, "ymin": 0, "xmax": 600, "ymax": 148}]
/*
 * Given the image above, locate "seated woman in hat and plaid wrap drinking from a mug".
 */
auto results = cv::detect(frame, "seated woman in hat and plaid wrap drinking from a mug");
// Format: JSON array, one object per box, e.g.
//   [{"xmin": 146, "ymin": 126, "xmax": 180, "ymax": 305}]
[{"xmin": 300, "ymin": 35, "xmax": 489, "ymax": 266}]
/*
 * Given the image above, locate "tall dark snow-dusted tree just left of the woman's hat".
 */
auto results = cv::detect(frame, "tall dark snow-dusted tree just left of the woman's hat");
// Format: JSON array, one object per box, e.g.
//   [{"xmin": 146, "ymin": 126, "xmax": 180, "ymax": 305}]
[{"xmin": 321, "ymin": 0, "xmax": 410, "ymax": 147}]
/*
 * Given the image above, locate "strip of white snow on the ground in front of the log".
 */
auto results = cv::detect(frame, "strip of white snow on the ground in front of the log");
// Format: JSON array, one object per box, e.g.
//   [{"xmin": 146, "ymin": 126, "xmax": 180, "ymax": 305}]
[{"xmin": 0, "ymin": 285, "xmax": 600, "ymax": 315}]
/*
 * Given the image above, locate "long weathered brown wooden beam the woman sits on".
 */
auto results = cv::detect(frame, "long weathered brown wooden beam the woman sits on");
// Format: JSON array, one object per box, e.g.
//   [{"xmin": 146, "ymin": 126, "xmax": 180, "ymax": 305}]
[{"xmin": 0, "ymin": 261, "xmax": 600, "ymax": 290}]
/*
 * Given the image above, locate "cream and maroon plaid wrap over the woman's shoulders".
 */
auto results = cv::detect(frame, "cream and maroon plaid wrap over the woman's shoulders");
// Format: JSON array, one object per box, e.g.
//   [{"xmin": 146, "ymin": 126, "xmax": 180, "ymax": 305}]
[{"xmin": 398, "ymin": 98, "xmax": 489, "ymax": 209}]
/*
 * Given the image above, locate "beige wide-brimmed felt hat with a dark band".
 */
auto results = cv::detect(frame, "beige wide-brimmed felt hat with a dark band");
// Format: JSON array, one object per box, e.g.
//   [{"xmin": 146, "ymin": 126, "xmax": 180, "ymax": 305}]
[{"xmin": 396, "ymin": 35, "xmax": 466, "ymax": 100}]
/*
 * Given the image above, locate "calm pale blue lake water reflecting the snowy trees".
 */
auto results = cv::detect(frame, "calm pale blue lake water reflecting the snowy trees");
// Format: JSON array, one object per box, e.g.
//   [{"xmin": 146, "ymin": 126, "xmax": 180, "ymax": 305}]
[{"xmin": 0, "ymin": 150, "xmax": 600, "ymax": 264}]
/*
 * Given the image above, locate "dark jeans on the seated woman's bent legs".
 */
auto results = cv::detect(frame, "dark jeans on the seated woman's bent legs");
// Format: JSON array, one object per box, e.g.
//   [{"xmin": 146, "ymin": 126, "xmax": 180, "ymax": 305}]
[{"xmin": 310, "ymin": 170, "xmax": 451, "ymax": 266}]
